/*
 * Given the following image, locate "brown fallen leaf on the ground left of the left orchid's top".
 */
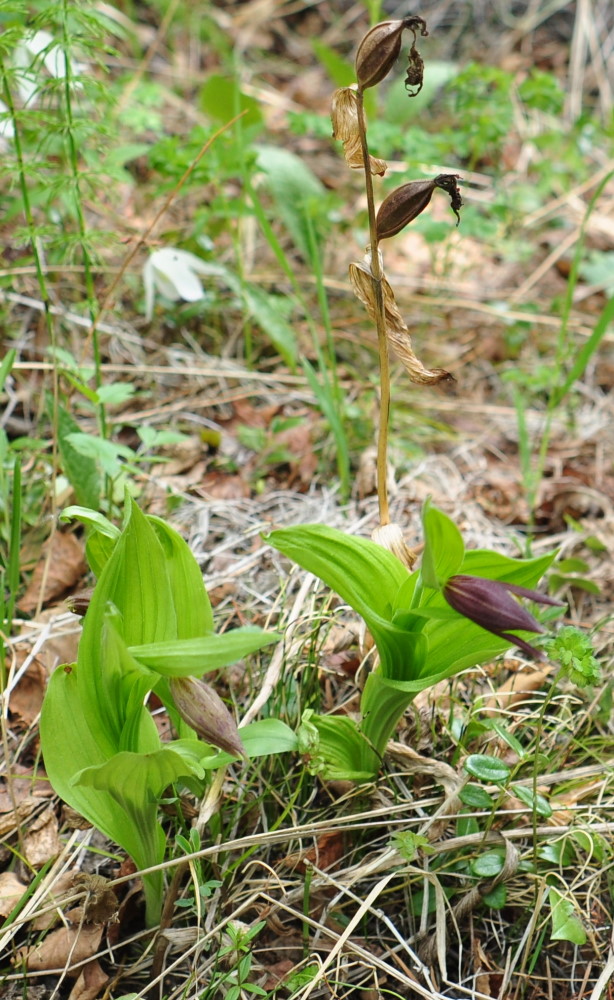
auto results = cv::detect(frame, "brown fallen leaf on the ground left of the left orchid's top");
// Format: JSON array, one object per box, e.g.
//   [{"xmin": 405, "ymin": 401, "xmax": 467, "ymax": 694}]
[{"xmin": 17, "ymin": 531, "xmax": 87, "ymax": 614}]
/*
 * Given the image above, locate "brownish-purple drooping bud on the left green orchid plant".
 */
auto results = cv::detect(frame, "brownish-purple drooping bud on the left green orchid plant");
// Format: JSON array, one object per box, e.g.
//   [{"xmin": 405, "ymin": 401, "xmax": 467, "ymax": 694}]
[{"xmin": 169, "ymin": 677, "xmax": 247, "ymax": 760}]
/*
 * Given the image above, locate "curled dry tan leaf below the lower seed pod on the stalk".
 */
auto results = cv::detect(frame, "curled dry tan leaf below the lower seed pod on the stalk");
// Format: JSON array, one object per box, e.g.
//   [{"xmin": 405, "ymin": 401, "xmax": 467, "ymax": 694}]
[{"xmin": 350, "ymin": 254, "xmax": 452, "ymax": 385}]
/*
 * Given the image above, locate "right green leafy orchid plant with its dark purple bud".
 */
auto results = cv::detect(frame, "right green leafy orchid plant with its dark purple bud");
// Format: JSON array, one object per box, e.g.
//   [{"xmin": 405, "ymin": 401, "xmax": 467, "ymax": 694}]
[{"xmin": 268, "ymin": 502, "xmax": 559, "ymax": 781}]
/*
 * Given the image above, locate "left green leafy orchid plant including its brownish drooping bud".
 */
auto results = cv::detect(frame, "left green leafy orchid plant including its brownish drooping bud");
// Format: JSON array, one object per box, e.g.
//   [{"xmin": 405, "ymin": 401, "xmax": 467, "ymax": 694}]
[{"xmin": 40, "ymin": 499, "xmax": 297, "ymax": 924}]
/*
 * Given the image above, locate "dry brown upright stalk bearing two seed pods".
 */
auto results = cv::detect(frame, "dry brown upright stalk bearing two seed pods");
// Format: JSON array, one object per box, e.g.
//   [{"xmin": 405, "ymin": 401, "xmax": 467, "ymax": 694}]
[{"xmin": 358, "ymin": 88, "xmax": 390, "ymax": 524}]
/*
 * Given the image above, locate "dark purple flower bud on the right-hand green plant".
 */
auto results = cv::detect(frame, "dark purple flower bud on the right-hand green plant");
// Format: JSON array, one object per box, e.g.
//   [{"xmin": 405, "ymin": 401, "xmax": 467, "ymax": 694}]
[{"xmin": 443, "ymin": 574, "xmax": 563, "ymax": 660}]
